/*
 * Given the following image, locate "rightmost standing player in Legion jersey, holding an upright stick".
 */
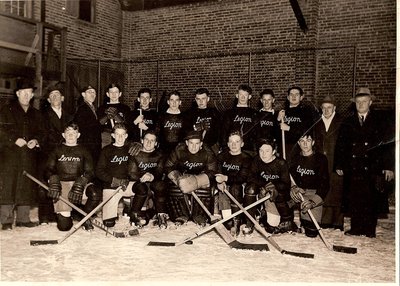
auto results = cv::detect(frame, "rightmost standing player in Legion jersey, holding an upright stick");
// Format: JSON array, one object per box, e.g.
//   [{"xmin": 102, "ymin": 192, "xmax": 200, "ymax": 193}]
[{"xmin": 278, "ymin": 86, "xmax": 315, "ymax": 162}]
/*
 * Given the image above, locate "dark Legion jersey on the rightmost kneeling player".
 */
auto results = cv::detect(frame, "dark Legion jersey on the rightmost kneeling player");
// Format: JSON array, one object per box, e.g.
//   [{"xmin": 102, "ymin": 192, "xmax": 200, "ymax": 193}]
[{"xmin": 290, "ymin": 153, "xmax": 329, "ymax": 199}]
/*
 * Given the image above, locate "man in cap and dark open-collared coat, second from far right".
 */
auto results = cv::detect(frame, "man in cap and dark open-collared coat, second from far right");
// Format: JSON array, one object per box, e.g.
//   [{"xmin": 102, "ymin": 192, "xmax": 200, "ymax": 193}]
[{"xmin": 314, "ymin": 95, "xmax": 344, "ymax": 230}]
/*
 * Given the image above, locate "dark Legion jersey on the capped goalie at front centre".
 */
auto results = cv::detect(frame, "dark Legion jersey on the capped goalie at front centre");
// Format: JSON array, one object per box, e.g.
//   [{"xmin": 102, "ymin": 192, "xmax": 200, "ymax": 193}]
[{"xmin": 165, "ymin": 143, "xmax": 217, "ymax": 181}]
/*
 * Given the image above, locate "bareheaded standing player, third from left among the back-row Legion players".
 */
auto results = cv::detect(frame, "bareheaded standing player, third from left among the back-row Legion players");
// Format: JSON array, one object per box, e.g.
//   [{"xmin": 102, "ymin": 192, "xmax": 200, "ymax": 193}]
[{"xmin": 157, "ymin": 91, "xmax": 184, "ymax": 155}]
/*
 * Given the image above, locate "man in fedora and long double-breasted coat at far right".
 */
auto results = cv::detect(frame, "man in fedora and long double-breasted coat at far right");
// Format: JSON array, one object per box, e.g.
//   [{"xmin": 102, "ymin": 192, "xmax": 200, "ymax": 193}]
[{"xmin": 335, "ymin": 87, "xmax": 394, "ymax": 237}]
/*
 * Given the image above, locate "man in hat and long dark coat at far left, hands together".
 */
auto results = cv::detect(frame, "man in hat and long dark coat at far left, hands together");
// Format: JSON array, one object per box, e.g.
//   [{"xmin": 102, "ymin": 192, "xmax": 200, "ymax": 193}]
[{"xmin": 0, "ymin": 79, "xmax": 45, "ymax": 230}]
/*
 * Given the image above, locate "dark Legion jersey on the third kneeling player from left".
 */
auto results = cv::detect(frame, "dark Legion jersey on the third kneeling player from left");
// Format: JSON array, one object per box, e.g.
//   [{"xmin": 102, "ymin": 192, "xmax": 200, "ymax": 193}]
[{"xmin": 128, "ymin": 150, "xmax": 164, "ymax": 181}]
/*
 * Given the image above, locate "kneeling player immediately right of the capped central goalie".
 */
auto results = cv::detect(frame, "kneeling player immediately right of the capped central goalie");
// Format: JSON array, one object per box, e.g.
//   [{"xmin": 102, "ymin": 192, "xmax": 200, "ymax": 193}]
[{"xmin": 215, "ymin": 131, "xmax": 251, "ymax": 235}]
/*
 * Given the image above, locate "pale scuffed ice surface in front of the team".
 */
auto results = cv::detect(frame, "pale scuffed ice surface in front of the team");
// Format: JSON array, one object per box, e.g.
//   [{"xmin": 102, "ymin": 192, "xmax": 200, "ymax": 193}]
[{"xmin": 0, "ymin": 208, "xmax": 396, "ymax": 285}]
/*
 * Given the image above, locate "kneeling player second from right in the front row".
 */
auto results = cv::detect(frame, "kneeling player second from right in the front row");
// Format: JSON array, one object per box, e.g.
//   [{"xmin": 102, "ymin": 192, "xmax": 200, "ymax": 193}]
[{"xmin": 245, "ymin": 139, "xmax": 297, "ymax": 233}]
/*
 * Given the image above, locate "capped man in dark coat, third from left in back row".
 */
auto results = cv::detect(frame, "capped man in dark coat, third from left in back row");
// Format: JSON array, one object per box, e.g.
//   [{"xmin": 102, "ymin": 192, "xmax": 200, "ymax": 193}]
[{"xmin": 74, "ymin": 85, "xmax": 101, "ymax": 165}]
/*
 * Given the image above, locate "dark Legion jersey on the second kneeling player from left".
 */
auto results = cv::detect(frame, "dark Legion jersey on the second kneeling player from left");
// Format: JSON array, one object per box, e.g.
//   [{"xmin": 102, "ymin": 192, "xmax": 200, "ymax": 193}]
[{"xmin": 96, "ymin": 144, "xmax": 129, "ymax": 188}]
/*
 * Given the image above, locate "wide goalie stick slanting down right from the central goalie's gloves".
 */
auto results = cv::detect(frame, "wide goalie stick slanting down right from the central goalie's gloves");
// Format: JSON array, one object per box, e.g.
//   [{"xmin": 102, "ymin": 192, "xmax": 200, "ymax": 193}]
[{"xmin": 191, "ymin": 192, "xmax": 269, "ymax": 251}]
